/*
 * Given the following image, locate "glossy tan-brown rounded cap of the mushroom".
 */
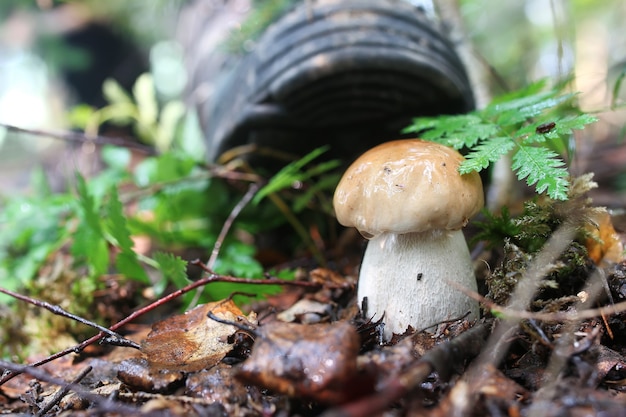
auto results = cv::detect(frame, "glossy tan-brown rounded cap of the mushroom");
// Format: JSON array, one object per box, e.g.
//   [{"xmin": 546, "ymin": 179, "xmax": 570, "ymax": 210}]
[{"xmin": 333, "ymin": 139, "xmax": 484, "ymax": 238}]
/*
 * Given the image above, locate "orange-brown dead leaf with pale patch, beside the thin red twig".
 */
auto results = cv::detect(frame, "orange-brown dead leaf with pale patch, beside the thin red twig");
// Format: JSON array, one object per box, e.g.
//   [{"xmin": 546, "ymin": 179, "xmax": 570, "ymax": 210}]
[{"xmin": 141, "ymin": 300, "xmax": 256, "ymax": 371}]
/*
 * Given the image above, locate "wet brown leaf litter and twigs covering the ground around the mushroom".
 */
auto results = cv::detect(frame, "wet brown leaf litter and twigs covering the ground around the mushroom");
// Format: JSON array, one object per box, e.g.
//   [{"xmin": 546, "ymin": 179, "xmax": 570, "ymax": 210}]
[{"xmin": 6, "ymin": 180, "xmax": 626, "ymax": 417}]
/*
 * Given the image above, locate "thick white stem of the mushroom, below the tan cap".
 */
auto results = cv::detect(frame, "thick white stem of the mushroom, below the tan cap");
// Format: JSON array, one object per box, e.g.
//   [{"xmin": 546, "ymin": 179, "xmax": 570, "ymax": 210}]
[{"xmin": 358, "ymin": 230, "xmax": 478, "ymax": 340}]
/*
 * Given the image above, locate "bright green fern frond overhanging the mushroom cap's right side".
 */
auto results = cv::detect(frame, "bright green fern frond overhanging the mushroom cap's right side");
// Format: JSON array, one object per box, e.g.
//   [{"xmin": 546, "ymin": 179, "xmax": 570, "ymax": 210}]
[{"xmin": 404, "ymin": 82, "xmax": 596, "ymax": 200}]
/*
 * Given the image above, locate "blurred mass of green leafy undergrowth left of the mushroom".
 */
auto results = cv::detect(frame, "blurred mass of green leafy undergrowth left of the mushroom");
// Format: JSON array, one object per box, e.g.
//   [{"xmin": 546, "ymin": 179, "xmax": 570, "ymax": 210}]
[{"xmin": 0, "ymin": 68, "xmax": 337, "ymax": 316}]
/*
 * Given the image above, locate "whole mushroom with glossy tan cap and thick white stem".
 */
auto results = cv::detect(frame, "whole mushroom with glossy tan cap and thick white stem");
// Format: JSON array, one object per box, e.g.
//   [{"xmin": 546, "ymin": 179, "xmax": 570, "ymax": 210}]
[{"xmin": 333, "ymin": 139, "xmax": 484, "ymax": 340}]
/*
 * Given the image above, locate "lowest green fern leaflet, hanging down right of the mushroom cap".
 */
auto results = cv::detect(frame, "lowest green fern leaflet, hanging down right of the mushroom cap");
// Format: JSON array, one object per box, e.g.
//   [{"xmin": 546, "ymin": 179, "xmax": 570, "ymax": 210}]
[{"xmin": 512, "ymin": 145, "xmax": 569, "ymax": 200}]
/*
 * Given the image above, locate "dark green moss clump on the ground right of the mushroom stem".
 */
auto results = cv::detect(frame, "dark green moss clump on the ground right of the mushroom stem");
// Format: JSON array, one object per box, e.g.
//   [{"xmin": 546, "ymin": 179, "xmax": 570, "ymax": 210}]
[{"xmin": 478, "ymin": 176, "xmax": 597, "ymax": 309}]
